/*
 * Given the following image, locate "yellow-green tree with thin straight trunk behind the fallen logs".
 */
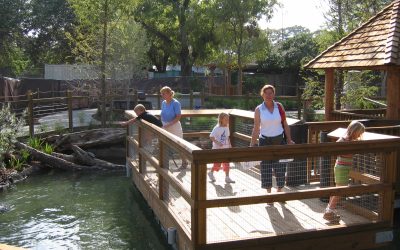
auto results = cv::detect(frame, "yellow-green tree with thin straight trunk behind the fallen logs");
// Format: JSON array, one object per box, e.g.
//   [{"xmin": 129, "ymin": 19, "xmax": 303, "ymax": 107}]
[{"xmin": 68, "ymin": 0, "xmax": 147, "ymax": 127}]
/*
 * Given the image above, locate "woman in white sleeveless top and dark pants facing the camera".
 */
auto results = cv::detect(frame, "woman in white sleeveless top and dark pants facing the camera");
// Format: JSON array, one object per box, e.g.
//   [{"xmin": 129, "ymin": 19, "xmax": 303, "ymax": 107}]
[{"xmin": 250, "ymin": 84, "xmax": 294, "ymax": 205}]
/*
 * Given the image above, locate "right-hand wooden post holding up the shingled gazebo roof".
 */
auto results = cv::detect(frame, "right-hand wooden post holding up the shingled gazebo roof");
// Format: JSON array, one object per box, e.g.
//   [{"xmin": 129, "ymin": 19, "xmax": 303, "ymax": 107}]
[{"xmin": 386, "ymin": 67, "xmax": 400, "ymax": 120}]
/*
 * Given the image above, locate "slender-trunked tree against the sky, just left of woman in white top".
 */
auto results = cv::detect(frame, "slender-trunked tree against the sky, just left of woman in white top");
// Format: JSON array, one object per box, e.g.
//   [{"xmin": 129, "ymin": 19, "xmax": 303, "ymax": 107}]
[{"xmin": 214, "ymin": 0, "xmax": 276, "ymax": 95}]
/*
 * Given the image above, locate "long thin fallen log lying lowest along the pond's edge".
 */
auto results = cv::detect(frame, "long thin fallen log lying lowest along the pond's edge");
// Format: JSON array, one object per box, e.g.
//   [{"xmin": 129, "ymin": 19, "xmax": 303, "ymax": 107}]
[{"xmin": 15, "ymin": 142, "xmax": 125, "ymax": 171}]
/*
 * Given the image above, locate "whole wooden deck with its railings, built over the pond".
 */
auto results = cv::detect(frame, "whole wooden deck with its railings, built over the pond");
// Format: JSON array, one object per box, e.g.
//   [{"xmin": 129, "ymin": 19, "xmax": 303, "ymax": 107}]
[{"xmin": 127, "ymin": 110, "xmax": 400, "ymax": 250}]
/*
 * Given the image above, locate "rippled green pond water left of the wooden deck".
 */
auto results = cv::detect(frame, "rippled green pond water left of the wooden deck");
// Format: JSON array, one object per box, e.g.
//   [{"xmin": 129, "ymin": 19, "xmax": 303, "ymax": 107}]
[{"xmin": 0, "ymin": 171, "xmax": 170, "ymax": 250}]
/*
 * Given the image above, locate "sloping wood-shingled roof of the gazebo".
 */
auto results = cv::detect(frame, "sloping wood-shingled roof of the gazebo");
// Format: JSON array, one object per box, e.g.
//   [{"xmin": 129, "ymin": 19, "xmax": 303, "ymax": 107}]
[{"xmin": 305, "ymin": 0, "xmax": 400, "ymax": 69}]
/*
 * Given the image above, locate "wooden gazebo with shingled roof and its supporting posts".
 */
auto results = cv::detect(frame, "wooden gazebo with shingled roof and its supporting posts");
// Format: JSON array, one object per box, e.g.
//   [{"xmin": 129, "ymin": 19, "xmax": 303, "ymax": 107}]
[{"xmin": 305, "ymin": 0, "xmax": 400, "ymax": 121}]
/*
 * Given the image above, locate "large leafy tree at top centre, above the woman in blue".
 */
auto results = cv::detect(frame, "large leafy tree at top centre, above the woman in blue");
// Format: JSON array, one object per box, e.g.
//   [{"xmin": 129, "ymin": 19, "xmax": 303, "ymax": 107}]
[{"xmin": 132, "ymin": 0, "xmax": 214, "ymax": 76}]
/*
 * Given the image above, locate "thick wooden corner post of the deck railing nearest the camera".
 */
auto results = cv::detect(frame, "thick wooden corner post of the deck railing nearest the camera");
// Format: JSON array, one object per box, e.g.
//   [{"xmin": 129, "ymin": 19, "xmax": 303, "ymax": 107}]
[{"xmin": 191, "ymin": 162, "xmax": 207, "ymax": 249}]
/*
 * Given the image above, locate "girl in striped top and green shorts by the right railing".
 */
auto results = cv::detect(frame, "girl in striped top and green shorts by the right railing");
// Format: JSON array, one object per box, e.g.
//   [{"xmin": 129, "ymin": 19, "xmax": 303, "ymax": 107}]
[{"xmin": 323, "ymin": 121, "xmax": 365, "ymax": 223}]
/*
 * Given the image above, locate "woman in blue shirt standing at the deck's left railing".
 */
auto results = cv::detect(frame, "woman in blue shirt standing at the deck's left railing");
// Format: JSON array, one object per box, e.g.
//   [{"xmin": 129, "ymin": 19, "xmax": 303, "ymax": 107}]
[{"xmin": 160, "ymin": 86, "xmax": 188, "ymax": 169}]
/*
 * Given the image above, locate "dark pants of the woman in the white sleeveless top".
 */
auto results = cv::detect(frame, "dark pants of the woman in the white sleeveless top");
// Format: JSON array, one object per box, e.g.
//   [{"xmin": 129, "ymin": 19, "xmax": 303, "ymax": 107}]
[{"xmin": 258, "ymin": 135, "xmax": 286, "ymax": 189}]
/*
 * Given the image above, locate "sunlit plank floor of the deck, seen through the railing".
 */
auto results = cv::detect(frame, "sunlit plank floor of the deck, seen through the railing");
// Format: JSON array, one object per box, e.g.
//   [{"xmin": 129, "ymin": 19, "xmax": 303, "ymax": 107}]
[{"xmin": 142, "ymin": 163, "xmax": 371, "ymax": 243}]
